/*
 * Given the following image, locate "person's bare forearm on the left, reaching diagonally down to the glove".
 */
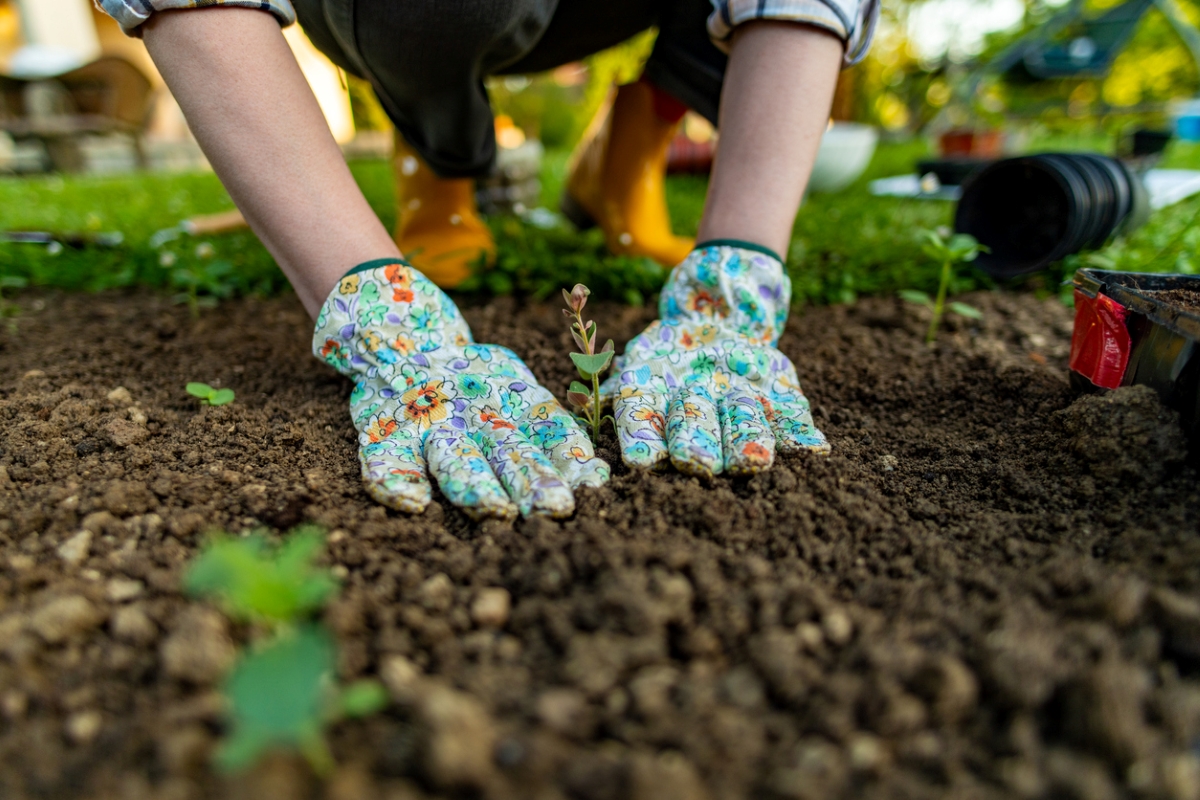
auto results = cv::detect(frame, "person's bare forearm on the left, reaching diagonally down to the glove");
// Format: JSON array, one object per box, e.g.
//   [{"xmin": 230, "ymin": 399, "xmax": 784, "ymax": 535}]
[{"xmin": 144, "ymin": 7, "xmax": 400, "ymax": 314}]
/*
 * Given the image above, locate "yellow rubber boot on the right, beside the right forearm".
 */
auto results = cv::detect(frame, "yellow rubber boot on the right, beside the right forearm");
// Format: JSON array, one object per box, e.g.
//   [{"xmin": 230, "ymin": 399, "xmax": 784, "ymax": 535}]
[{"xmin": 562, "ymin": 82, "xmax": 695, "ymax": 266}]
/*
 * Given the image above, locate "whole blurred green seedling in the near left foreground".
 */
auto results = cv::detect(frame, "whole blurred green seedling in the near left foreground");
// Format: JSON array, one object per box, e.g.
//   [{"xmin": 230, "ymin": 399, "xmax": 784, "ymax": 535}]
[{"xmin": 184, "ymin": 528, "xmax": 388, "ymax": 775}]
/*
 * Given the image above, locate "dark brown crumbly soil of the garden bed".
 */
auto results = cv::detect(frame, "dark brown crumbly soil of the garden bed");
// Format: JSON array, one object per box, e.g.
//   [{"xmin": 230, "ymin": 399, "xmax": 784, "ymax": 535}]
[{"xmin": 0, "ymin": 294, "xmax": 1200, "ymax": 800}]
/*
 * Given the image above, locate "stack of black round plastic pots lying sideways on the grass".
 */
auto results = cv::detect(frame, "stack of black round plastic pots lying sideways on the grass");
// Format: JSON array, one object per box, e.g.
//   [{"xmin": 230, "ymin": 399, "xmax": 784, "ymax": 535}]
[{"xmin": 954, "ymin": 152, "xmax": 1150, "ymax": 278}]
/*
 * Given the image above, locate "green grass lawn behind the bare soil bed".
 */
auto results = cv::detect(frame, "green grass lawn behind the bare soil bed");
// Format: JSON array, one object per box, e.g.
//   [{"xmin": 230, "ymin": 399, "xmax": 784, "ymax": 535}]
[{"xmin": 0, "ymin": 140, "xmax": 1200, "ymax": 305}]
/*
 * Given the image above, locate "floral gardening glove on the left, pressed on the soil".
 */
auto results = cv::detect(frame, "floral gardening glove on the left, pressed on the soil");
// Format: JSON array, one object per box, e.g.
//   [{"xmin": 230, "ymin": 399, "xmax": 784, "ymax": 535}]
[{"xmin": 312, "ymin": 259, "xmax": 608, "ymax": 518}]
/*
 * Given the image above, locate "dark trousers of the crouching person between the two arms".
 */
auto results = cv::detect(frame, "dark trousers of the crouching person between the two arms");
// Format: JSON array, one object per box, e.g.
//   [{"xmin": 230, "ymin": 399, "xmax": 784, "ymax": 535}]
[{"xmin": 295, "ymin": 0, "xmax": 725, "ymax": 178}]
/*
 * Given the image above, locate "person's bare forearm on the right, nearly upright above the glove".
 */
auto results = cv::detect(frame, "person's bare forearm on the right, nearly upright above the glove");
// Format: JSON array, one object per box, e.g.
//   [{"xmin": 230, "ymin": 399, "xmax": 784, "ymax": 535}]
[{"xmin": 696, "ymin": 22, "xmax": 842, "ymax": 258}]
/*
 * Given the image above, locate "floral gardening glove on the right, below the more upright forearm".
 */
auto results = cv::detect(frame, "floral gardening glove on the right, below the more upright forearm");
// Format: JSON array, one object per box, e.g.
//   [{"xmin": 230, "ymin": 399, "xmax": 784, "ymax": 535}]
[{"xmin": 601, "ymin": 242, "xmax": 829, "ymax": 475}]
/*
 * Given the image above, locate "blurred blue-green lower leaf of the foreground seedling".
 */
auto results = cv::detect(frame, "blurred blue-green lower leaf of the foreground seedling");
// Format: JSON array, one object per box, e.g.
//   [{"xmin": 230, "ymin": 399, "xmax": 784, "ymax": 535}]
[{"xmin": 216, "ymin": 626, "xmax": 336, "ymax": 772}]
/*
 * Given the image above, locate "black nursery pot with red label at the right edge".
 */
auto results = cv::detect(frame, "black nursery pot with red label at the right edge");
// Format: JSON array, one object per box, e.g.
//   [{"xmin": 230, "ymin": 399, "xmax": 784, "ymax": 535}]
[{"xmin": 1070, "ymin": 269, "xmax": 1200, "ymax": 449}]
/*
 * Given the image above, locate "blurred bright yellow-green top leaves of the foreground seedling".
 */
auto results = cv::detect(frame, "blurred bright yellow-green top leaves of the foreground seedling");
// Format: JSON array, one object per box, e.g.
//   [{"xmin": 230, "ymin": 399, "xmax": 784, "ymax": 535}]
[{"xmin": 184, "ymin": 528, "xmax": 337, "ymax": 622}]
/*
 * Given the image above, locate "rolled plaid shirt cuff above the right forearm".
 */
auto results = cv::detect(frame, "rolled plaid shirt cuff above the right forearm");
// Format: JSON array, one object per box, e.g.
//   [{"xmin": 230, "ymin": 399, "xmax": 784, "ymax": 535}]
[{"xmin": 708, "ymin": 0, "xmax": 880, "ymax": 67}]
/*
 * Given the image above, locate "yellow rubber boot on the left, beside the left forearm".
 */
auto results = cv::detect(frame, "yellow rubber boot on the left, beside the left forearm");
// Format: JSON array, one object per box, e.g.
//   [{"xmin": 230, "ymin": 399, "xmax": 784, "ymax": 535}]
[{"xmin": 391, "ymin": 133, "xmax": 496, "ymax": 289}]
